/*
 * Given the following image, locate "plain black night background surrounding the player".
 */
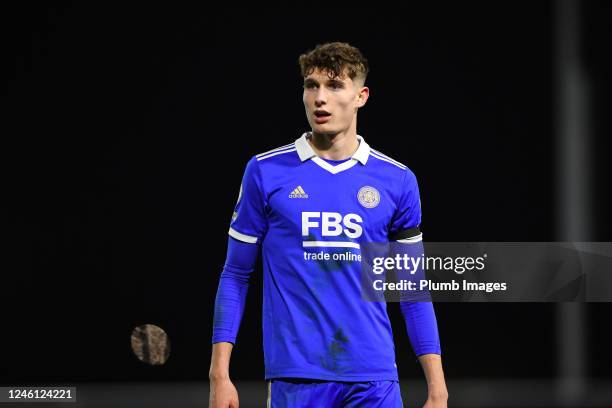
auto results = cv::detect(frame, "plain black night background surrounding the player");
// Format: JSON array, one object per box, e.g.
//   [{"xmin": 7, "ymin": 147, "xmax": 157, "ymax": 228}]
[{"xmin": 0, "ymin": 1, "xmax": 612, "ymax": 384}]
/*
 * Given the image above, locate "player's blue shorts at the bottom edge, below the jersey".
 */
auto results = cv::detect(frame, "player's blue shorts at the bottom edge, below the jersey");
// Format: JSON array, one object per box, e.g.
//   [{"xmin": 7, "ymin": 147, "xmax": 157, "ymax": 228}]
[{"xmin": 267, "ymin": 378, "xmax": 404, "ymax": 408}]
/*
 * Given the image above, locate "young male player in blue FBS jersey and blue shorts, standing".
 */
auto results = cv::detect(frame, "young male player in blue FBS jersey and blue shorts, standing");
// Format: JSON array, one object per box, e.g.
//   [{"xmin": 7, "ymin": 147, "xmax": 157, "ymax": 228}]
[{"xmin": 209, "ymin": 42, "xmax": 447, "ymax": 408}]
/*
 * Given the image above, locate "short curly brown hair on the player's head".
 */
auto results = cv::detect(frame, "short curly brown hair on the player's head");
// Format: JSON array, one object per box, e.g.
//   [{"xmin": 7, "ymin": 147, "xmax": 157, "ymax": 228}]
[{"xmin": 298, "ymin": 42, "xmax": 369, "ymax": 83}]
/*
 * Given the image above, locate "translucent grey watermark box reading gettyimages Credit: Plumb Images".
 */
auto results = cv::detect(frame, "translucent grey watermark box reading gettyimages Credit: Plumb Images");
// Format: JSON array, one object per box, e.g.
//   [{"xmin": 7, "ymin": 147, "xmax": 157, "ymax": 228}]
[{"xmin": 360, "ymin": 242, "xmax": 612, "ymax": 302}]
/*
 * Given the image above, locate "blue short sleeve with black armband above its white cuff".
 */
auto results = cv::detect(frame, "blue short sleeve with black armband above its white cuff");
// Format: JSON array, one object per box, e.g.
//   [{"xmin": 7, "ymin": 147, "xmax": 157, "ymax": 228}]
[{"xmin": 389, "ymin": 169, "xmax": 422, "ymax": 243}]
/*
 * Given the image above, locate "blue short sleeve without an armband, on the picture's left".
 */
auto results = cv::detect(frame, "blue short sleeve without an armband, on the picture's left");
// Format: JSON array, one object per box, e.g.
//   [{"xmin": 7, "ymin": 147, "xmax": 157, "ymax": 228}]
[{"xmin": 229, "ymin": 157, "xmax": 268, "ymax": 244}]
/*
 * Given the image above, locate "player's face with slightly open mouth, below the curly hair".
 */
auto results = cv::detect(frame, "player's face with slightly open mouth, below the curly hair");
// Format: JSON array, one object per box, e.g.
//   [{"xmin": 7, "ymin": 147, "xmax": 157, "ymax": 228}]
[{"xmin": 303, "ymin": 68, "xmax": 368, "ymax": 135}]
